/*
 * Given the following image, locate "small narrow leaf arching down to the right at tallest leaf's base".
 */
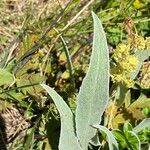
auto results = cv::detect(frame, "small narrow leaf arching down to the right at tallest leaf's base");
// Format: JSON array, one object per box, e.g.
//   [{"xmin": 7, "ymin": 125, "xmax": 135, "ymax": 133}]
[{"xmin": 93, "ymin": 125, "xmax": 118, "ymax": 150}]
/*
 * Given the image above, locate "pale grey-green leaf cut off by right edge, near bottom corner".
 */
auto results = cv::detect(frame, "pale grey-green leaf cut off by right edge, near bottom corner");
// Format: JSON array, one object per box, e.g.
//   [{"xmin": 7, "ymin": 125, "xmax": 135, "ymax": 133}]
[{"xmin": 133, "ymin": 118, "xmax": 150, "ymax": 133}]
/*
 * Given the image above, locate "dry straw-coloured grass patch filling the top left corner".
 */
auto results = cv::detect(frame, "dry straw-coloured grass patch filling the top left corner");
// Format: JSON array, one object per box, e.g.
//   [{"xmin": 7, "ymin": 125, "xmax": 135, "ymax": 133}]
[{"xmin": 0, "ymin": 0, "xmax": 69, "ymax": 49}]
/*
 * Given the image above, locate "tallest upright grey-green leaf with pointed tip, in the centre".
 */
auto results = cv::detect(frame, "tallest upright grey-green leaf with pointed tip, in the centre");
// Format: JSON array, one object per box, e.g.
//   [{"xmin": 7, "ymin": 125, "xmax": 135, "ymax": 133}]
[{"xmin": 76, "ymin": 13, "xmax": 109, "ymax": 150}]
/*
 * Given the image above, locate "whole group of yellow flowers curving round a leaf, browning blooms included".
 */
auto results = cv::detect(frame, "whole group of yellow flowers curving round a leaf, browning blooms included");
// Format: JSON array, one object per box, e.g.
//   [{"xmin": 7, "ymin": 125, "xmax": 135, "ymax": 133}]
[{"xmin": 111, "ymin": 35, "xmax": 150, "ymax": 88}]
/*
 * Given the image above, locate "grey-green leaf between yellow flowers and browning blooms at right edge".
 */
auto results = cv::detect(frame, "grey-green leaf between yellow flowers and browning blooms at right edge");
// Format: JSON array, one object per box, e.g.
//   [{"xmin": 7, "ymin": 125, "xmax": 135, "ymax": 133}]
[{"xmin": 130, "ymin": 50, "xmax": 150, "ymax": 80}]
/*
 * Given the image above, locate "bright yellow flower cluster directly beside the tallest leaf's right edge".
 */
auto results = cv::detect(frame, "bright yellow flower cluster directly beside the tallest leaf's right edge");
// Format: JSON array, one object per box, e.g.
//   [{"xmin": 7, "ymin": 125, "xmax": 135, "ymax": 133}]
[{"xmin": 111, "ymin": 43, "xmax": 138, "ymax": 88}]
